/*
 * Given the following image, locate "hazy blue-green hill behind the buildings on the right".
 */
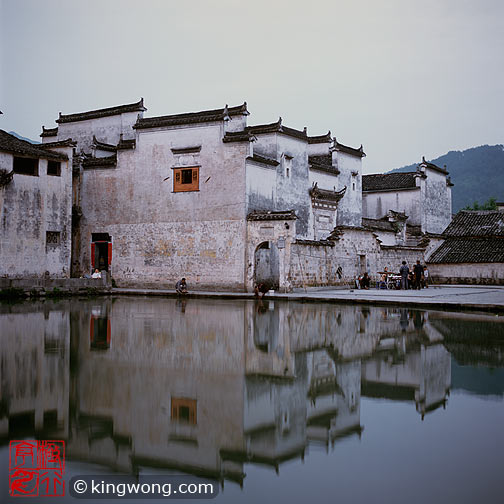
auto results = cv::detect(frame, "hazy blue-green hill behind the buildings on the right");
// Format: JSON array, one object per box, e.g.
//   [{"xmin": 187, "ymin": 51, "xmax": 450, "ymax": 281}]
[{"xmin": 389, "ymin": 145, "xmax": 504, "ymax": 213}]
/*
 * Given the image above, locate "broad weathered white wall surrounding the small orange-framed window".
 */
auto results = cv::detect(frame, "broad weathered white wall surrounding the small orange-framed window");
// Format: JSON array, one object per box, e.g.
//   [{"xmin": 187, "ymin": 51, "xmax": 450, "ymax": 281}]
[{"xmin": 81, "ymin": 123, "xmax": 249, "ymax": 290}]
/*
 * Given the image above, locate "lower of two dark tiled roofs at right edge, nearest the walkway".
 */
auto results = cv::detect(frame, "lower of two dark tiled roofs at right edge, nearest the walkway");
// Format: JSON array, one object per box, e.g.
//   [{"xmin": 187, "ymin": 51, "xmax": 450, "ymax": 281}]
[{"xmin": 427, "ymin": 237, "xmax": 504, "ymax": 264}]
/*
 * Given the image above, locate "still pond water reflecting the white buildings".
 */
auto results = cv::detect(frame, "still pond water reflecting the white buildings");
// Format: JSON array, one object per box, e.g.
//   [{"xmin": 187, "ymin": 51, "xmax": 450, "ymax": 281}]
[{"xmin": 0, "ymin": 297, "xmax": 504, "ymax": 504}]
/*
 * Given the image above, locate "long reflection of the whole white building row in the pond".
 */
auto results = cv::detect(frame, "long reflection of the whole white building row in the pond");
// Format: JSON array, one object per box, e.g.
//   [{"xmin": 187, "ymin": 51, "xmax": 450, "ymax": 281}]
[{"xmin": 0, "ymin": 299, "xmax": 464, "ymax": 482}]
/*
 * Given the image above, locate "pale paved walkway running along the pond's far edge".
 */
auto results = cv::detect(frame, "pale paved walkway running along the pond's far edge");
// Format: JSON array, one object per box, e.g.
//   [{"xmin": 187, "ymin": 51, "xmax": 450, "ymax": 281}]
[{"xmin": 112, "ymin": 285, "xmax": 504, "ymax": 312}]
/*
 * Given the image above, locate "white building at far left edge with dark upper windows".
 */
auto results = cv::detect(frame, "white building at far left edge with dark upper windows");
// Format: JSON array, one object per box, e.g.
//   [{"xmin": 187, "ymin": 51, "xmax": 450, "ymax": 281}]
[{"xmin": 0, "ymin": 130, "xmax": 72, "ymax": 278}]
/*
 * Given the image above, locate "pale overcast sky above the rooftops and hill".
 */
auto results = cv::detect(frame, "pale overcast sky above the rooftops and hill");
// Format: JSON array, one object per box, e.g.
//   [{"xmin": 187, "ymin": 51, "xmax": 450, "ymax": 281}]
[{"xmin": 0, "ymin": 0, "xmax": 504, "ymax": 173}]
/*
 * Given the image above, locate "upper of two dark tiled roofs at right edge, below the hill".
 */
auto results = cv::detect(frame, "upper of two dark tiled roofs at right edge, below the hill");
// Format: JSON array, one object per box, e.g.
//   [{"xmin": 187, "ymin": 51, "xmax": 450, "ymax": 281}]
[{"xmin": 443, "ymin": 210, "xmax": 504, "ymax": 237}]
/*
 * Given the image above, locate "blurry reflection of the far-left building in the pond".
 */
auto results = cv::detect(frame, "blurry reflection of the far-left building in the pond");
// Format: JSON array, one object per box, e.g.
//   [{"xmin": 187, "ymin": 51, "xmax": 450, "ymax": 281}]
[{"xmin": 0, "ymin": 301, "xmax": 70, "ymax": 438}]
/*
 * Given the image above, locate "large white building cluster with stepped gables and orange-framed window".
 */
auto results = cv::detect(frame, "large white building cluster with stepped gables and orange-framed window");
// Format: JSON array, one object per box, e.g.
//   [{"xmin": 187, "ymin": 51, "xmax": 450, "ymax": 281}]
[{"xmin": 35, "ymin": 100, "xmax": 451, "ymax": 291}]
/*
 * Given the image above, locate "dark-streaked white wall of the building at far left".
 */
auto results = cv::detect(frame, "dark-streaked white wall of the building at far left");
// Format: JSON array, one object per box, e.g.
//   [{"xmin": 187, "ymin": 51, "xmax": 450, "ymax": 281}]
[{"xmin": 0, "ymin": 149, "xmax": 72, "ymax": 278}]
